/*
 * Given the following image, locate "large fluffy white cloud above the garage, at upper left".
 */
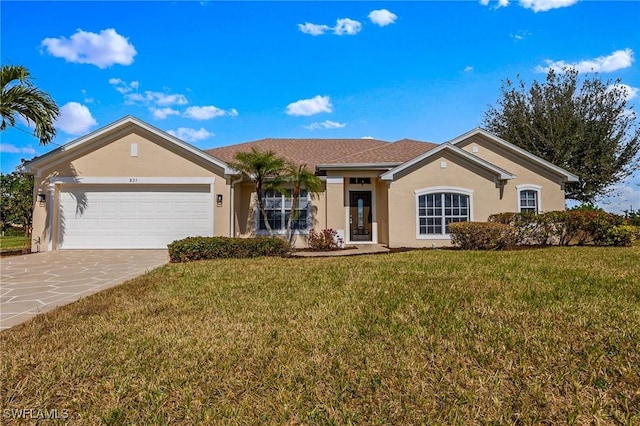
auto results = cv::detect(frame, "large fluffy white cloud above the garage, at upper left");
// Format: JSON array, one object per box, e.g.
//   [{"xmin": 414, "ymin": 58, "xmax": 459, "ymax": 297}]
[{"xmin": 41, "ymin": 28, "xmax": 137, "ymax": 69}]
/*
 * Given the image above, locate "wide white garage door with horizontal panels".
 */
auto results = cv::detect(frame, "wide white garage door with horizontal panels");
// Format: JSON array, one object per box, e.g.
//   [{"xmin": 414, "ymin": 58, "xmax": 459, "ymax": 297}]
[{"xmin": 58, "ymin": 184, "xmax": 213, "ymax": 249}]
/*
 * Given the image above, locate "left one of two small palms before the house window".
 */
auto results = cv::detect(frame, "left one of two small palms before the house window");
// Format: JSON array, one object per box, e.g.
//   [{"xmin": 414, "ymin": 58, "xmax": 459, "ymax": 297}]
[{"xmin": 229, "ymin": 147, "xmax": 286, "ymax": 233}]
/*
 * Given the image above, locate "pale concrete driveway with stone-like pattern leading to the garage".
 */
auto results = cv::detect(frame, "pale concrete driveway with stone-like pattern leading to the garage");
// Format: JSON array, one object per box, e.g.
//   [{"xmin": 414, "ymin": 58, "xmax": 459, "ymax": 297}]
[{"xmin": 0, "ymin": 250, "xmax": 169, "ymax": 330}]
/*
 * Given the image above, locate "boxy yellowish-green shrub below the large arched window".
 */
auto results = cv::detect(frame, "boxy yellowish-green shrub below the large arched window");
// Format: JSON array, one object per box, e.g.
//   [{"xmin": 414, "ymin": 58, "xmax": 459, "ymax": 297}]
[{"xmin": 449, "ymin": 222, "xmax": 517, "ymax": 250}]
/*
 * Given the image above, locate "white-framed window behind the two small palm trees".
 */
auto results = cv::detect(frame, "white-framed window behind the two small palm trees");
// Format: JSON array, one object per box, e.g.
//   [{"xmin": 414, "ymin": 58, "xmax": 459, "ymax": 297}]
[{"xmin": 257, "ymin": 189, "xmax": 309, "ymax": 231}]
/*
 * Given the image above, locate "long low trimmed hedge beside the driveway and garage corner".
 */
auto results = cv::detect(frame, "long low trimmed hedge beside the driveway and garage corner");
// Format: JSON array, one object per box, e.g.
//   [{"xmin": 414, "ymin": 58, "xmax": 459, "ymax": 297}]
[{"xmin": 168, "ymin": 237, "xmax": 291, "ymax": 263}]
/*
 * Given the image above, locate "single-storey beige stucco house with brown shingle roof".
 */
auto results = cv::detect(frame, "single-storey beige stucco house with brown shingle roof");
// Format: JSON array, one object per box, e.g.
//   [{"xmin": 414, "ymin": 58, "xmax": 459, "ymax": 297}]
[{"xmin": 24, "ymin": 116, "xmax": 577, "ymax": 251}]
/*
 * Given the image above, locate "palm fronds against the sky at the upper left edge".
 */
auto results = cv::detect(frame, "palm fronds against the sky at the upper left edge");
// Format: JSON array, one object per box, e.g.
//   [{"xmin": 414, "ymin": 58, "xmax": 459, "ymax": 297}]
[{"xmin": 0, "ymin": 65, "xmax": 60, "ymax": 145}]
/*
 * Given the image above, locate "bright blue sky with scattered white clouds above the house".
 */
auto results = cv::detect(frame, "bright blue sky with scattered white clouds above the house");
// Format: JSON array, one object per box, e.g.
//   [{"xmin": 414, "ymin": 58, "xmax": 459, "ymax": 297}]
[{"xmin": 0, "ymin": 0, "xmax": 640, "ymax": 211}]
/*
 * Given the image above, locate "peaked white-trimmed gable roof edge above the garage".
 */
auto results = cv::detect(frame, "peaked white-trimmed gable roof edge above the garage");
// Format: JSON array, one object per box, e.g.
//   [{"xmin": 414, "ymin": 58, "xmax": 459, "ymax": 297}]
[{"xmin": 23, "ymin": 116, "xmax": 233, "ymax": 173}]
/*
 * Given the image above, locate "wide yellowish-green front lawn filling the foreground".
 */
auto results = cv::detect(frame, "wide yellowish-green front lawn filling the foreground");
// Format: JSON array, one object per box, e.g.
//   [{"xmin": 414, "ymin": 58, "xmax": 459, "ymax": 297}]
[{"xmin": 0, "ymin": 246, "xmax": 640, "ymax": 425}]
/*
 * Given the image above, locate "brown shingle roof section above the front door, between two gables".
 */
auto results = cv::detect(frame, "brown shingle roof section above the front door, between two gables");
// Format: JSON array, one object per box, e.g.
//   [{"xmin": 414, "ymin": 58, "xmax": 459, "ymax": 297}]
[{"xmin": 206, "ymin": 138, "xmax": 437, "ymax": 170}]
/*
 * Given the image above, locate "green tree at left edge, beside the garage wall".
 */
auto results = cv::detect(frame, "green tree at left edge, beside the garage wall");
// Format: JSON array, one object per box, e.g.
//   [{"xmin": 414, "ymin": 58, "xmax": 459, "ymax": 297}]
[{"xmin": 0, "ymin": 172, "xmax": 33, "ymax": 235}]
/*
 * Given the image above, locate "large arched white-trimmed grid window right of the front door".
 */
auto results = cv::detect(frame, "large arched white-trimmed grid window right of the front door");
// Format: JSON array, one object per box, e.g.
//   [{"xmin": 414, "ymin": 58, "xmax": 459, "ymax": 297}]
[{"xmin": 416, "ymin": 189, "xmax": 472, "ymax": 238}]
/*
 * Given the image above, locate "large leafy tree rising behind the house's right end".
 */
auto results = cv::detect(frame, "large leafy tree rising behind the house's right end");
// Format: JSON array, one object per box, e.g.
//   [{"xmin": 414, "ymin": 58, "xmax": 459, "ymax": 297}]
[{"xmin": 483, "ymin": 68, "xmax": 640, "ymax": 203}]
